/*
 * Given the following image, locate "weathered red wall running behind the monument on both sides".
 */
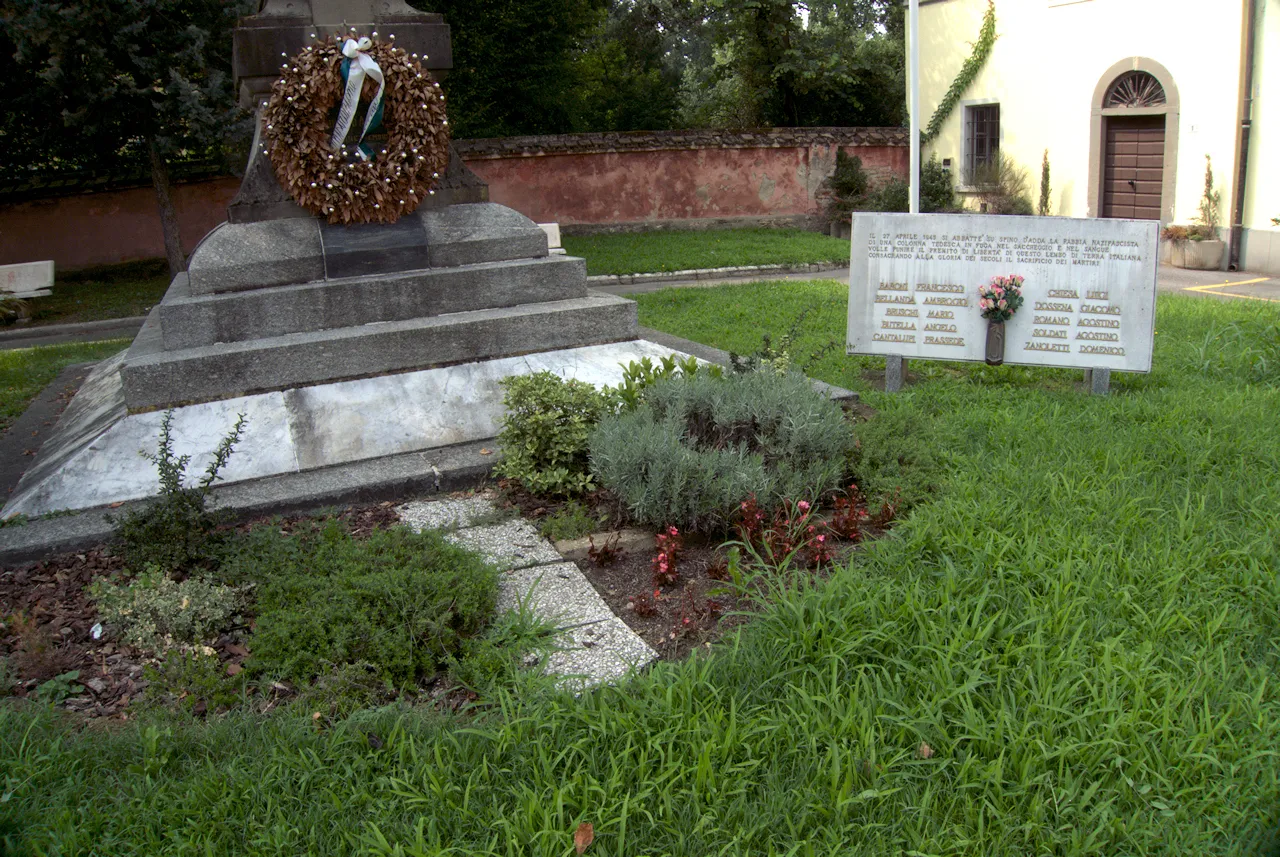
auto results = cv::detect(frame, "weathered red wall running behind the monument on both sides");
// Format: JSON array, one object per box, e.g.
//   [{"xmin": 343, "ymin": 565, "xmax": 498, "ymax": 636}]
[{"xmin": 0, "ymin": 128, "xmax": 908, "ymax": 269}]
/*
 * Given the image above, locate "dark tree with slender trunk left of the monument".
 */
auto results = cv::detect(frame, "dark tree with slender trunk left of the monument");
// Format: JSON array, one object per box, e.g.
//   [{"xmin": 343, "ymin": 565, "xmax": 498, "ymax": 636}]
[{"xmin": 0, "ymin": 0, "xmax": 256, "ymax": 274}]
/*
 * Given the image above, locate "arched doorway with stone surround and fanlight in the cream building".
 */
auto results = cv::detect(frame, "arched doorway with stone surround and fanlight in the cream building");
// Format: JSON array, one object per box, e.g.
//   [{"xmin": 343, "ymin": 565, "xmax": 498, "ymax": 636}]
[{"xmin": 1089, "ymin": 56, "xmax": 1178, "ymax": 223}]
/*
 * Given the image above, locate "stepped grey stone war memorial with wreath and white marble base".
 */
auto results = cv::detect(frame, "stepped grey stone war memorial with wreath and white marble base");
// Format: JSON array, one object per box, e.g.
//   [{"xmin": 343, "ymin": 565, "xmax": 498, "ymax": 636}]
[{"xmin": 3, "ymin": 0, "xmax": 691, "ymax": 517}]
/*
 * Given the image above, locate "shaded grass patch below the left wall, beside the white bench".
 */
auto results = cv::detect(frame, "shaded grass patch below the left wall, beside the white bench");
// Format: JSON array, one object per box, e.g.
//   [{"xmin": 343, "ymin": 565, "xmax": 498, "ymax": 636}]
[{"xmin": 15, "ymin": 258, "xmax": 170, "ymax": 325}]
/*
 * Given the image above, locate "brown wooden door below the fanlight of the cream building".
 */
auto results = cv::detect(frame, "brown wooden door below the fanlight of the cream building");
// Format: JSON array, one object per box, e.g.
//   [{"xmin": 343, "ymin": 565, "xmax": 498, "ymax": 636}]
[{"xmin": 1102, "ymin": 116, "xmax": 1165, "ymax": 220}]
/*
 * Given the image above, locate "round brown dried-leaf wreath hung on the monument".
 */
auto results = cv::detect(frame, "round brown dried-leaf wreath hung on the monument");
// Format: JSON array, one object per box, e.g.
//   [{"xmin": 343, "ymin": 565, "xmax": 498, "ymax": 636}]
[{"xmin": 264, "ymin": 36, "xmax": 449, "ymax": 224}]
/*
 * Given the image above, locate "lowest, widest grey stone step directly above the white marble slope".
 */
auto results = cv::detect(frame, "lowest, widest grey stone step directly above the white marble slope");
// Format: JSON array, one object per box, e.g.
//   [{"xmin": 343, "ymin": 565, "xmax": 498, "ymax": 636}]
[{"xmin": 120, "ymin": 294, "xmax": 637, "ymax": 412}]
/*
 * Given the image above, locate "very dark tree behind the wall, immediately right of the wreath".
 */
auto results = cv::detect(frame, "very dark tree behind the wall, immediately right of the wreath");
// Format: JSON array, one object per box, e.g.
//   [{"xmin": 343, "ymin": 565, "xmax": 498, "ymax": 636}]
[{"xmin": 410, "ymin": 0, "xmax": 609, "ymax": 137}]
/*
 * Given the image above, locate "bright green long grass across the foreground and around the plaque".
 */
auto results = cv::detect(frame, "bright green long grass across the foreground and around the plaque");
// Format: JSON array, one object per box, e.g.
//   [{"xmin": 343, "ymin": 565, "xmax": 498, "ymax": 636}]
[{"xmin": 0, "ymin": 283, "xmax": 1280, "ymax": 857}]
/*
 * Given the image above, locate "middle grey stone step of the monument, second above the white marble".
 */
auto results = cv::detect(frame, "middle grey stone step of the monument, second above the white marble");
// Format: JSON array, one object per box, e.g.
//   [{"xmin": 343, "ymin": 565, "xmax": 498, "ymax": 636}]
[{"xmin": 160, "ymin": 256, "xmax": 586, "ymax": 350}]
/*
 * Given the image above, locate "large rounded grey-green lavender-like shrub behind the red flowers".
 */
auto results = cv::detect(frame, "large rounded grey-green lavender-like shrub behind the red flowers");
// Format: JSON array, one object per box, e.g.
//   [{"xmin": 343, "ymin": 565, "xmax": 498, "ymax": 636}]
[{"xmin": 591, "ymin": 372, "xmax": 852, "ymax": 530}]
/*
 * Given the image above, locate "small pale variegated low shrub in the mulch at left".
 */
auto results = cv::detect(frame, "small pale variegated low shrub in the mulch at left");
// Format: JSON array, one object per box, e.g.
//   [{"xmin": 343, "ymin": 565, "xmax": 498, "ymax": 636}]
[{"xmin": 90, "ymin": 564, "xmax": 239, "ymax": 651}]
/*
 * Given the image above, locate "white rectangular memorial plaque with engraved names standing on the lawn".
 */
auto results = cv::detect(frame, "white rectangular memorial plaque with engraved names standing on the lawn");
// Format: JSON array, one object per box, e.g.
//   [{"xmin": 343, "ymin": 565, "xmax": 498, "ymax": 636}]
[{"xmin": 847, "ymin": 214, "xmax": 1160, "ymax": 372}]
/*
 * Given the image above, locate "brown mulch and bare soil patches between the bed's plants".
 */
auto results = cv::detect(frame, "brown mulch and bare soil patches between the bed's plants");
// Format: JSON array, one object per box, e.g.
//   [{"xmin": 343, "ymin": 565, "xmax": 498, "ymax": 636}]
[{"xmin": 0, "ymin": 482, "xmax": 883, "ymax": 720}]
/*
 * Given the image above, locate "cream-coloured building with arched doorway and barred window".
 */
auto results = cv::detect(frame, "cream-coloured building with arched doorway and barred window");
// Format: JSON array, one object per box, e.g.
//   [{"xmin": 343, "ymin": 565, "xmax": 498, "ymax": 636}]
[{"xmin": 920, "ymin": 0, "xmax": 1280, "ymax": 272}]
